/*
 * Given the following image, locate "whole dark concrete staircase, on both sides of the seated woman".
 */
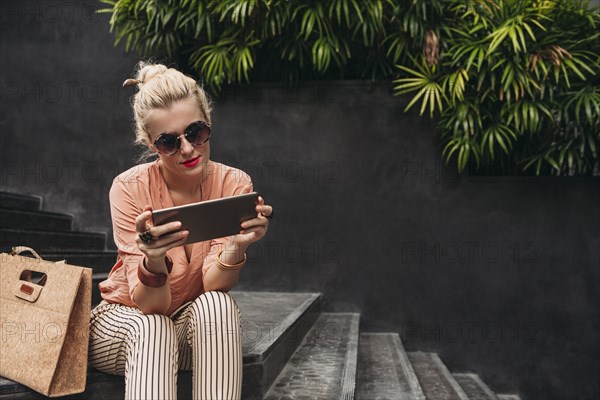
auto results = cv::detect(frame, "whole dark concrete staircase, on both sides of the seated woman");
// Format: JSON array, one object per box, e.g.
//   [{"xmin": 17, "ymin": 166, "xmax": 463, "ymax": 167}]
[{"xmin": 0, "ymin": 192, "xmax": 520, "ymax": 400}]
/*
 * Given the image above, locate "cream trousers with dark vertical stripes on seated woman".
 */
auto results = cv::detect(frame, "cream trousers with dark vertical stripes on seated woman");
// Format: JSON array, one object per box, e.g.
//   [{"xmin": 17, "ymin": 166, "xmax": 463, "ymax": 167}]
[{"xmin": 89, "ymin": 291, "xmax": 243, "ymax": 400}]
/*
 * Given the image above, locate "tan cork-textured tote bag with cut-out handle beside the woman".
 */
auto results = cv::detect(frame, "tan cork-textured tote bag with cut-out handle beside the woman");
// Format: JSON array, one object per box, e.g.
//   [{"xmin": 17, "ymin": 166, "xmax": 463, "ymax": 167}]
[{"xmin": 0, "ymin": 247, "xmax": 92, "ymax": 397}]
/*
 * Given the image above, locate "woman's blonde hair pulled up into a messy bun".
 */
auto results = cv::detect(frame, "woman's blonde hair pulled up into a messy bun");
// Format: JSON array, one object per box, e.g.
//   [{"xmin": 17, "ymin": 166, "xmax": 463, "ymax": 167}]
[{"xmin": 123, "ymin": 61, "xmax": 212, "ymax": 150}]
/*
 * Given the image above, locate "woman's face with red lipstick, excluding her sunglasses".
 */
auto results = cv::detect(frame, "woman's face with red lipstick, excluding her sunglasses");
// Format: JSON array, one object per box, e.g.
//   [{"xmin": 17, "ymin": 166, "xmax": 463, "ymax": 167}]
[{"xmin": 146, "ymin": 99, "xmax": 210, "ymax": 181}]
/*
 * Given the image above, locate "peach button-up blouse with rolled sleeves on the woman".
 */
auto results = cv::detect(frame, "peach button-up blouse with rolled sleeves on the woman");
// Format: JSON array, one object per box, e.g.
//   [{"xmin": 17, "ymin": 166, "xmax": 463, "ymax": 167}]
[{"xmin": 99, "ymin": 160, "xmax": 253, "ymax": 315}]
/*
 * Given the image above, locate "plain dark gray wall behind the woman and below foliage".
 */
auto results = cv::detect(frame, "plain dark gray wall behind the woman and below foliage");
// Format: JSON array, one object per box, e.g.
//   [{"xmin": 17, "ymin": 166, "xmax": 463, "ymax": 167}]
[{"xmin": 0, "ymin": 1, "xmax": 600, "ymax": 400}]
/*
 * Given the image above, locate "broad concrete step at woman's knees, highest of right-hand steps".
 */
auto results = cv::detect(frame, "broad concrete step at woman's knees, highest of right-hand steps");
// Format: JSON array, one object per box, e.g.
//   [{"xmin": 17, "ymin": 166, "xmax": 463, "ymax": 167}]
[{"xmin": 0, "ymin": 291, "xmax": 324, "ymax": 400}]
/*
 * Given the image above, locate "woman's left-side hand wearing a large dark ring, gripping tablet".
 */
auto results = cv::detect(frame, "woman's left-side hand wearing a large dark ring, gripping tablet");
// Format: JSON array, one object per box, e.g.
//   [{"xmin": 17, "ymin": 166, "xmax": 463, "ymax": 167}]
[{"xmin": 135, "ymin": 206, "xmax": 189, "ymax": 272}]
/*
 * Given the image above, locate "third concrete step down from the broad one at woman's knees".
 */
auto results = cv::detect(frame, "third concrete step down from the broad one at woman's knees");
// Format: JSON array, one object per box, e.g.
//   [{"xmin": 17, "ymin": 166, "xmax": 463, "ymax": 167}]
[{"xmin": 408, "ymin": 351, "xmax": 469, "ymax": 400}]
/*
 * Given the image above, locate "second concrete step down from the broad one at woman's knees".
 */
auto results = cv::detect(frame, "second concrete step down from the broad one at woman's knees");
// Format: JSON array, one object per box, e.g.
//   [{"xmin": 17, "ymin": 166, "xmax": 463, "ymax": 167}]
[{"xmin": 356, "ymin": 333, "xmax": 425, "ymax": 400}]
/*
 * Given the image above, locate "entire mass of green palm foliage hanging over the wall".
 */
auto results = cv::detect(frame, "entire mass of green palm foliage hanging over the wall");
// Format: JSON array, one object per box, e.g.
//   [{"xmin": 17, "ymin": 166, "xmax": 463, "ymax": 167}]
[{"xmin": 100, "ymin": 0, "xmax": 600, "ymax": 175}]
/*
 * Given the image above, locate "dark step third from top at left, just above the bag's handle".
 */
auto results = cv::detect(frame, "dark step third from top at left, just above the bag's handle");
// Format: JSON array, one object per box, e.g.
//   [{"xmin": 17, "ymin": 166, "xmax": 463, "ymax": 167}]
[{"xmin": 0, "ymin": 228, "xmax": 106, "ymax": 253}]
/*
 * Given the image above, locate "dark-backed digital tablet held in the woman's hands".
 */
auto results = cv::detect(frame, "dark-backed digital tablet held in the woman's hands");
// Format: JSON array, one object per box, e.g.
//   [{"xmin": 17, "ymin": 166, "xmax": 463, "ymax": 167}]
[{"xmin": 152, "ymin": 192, "xmax": 258, "ymax": 244}]
